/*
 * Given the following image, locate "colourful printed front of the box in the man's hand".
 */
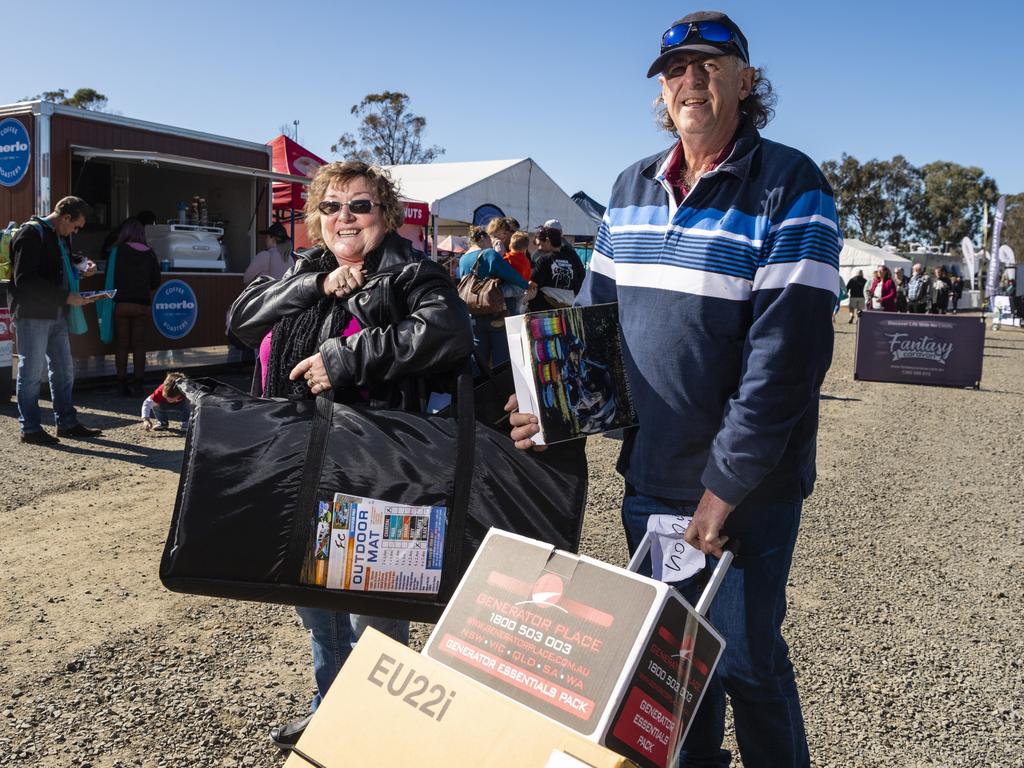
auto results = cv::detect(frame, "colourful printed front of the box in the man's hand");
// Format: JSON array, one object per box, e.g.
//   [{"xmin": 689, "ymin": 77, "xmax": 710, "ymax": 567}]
[{"xmin": 525, "ymin": 304, "xmax": 636, "ymax": 442}]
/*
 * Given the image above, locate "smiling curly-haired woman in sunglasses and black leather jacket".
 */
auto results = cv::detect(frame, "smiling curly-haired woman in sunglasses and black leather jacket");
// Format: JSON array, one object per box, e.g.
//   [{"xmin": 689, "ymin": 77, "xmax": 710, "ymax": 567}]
[{"xmin": 229, "ymin": 162, "xmax": 472, "ymax": 749}]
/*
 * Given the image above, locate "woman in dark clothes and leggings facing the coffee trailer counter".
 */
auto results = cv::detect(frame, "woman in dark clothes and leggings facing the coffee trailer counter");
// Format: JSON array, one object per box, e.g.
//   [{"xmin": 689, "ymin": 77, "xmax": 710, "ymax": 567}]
[{"xmin": 106, "ymin": 219, "xmax": 160, "ymax": 396}]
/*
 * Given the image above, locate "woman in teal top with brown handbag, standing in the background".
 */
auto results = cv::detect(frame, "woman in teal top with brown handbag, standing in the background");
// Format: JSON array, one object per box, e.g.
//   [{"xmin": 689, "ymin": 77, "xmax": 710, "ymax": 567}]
[{"xmin": 459, "ymin": 226, "xmax": 531, "ymax": 368}]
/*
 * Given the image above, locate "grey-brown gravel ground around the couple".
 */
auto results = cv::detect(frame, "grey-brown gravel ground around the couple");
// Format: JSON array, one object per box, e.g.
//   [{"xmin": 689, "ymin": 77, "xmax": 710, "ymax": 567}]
[{"xmin": 0, "ymin": 325, "xmax": 1024, "ymax": 768}]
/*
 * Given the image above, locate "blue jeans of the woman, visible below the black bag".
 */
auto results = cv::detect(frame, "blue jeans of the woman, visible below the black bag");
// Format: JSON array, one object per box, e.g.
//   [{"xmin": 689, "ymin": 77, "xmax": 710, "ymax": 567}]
[{"xmin": 295, "ymin": 607, "xmax": 409, "ymax": 712}]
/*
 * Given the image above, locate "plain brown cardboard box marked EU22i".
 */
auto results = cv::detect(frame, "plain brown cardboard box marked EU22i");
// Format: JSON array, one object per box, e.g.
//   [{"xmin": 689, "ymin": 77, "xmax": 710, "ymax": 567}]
[{"xmin": 285, "ymin": 629, "xmax": 633, "ymax": 768}]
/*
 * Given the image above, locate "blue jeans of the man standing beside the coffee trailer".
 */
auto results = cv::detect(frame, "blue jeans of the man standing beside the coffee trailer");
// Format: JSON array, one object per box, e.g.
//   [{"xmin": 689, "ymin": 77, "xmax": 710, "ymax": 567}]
[{"xmin": 14, "ymin": 317, "xmax": 78, "ymax": 434}]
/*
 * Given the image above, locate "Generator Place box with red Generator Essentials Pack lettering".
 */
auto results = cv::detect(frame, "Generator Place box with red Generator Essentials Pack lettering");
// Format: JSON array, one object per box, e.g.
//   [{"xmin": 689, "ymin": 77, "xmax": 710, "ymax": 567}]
[{"xmin": 423, "ymin": 529, "xmax": 725, "ymax": 768}]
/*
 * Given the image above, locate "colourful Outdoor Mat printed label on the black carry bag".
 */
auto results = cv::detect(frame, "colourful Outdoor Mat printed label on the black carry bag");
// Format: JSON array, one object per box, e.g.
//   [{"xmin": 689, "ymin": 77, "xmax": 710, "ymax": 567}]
[{"xmin": 304, "ymin": 494, "xmax": 447, "ymax": 594}]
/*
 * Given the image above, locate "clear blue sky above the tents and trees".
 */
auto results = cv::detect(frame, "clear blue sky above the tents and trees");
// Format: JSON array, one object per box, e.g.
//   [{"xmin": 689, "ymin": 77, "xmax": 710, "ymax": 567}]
[{"xmin": 6, "ymin": 0, "xmax": 1024, "ymax": 203}]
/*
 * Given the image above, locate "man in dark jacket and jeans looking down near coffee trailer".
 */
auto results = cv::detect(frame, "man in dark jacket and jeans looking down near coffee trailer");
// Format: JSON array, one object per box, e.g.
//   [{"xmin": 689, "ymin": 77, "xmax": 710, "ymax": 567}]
[{"xmin": 10, "ymin": 198, "xmax": 100, "ymax": 445}]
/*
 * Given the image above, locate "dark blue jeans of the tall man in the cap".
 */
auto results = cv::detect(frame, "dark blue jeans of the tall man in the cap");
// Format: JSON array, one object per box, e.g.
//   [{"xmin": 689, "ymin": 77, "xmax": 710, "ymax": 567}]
[{"xmin": 623, "ymin": 488, "xmax": 810, "ymax": 768}]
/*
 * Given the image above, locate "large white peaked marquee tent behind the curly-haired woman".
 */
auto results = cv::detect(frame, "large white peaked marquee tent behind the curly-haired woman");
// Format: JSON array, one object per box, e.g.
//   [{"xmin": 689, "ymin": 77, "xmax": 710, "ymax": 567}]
[{"xmin": 387, "ymin": 158, "xmax": 598, "ymax": 243}]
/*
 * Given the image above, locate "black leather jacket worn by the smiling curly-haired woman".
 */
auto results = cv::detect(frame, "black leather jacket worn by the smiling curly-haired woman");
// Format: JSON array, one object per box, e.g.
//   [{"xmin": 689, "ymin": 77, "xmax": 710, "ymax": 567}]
[{"xmin": 228, "ymin": 232, "xmax": 473, "ymax": 410}]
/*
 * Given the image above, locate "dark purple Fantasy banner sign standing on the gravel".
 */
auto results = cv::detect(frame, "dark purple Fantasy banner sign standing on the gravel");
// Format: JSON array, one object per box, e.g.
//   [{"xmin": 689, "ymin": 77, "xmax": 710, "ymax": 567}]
[{"xmin": 853, "ymin": 311, "xmax": 985, "ymax": 387}]
